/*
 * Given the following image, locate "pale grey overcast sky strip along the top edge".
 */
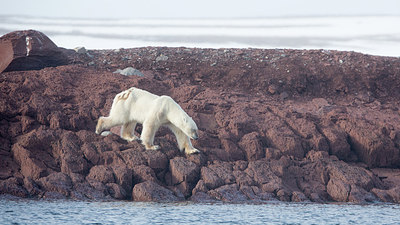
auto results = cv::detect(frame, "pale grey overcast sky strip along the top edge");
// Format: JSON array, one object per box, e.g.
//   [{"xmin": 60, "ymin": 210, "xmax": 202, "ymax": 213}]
[{"xmin": 0, "ymin": 0, "xmax": 400, "ymax": 18}]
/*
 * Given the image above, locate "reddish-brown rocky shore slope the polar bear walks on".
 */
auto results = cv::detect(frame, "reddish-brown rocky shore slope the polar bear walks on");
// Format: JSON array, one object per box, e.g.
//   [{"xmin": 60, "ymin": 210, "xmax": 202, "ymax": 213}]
[{"xmin": 0, "ymin": 30, "xmax": 400, "ymax": 203}]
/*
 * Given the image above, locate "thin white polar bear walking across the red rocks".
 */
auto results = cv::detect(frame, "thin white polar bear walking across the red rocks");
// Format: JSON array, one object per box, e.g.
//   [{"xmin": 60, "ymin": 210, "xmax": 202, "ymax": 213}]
[{"xmin": 96, "ymin": 87, "xmax": 199, "ymax": 154}]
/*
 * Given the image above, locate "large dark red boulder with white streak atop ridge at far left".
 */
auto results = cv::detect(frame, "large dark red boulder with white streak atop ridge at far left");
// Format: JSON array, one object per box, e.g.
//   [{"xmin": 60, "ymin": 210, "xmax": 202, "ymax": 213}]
[{"xmin": 0, "ymin": 30, "xmax": 69, "ymax": 72}]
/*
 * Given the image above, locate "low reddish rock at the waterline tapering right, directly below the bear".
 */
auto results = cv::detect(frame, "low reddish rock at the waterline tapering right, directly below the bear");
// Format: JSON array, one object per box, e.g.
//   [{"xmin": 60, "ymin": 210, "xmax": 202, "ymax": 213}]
[{"xmin": 132, "ymin": 181, "xmax": 183, "ymax": 202}]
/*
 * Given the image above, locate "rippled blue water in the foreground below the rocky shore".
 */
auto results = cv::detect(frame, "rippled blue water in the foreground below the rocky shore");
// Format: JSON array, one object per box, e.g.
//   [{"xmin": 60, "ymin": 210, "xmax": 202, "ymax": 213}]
[{"xmin": 0, "ymin": 199, "xmax": 400, "ymax": 225}]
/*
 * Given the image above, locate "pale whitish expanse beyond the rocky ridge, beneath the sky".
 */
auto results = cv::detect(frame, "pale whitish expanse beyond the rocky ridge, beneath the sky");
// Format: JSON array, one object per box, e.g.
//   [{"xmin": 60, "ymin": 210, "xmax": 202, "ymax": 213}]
[{"xmin": 0, "ymin": 15, "xmax": 400, "ymax": 57}]
